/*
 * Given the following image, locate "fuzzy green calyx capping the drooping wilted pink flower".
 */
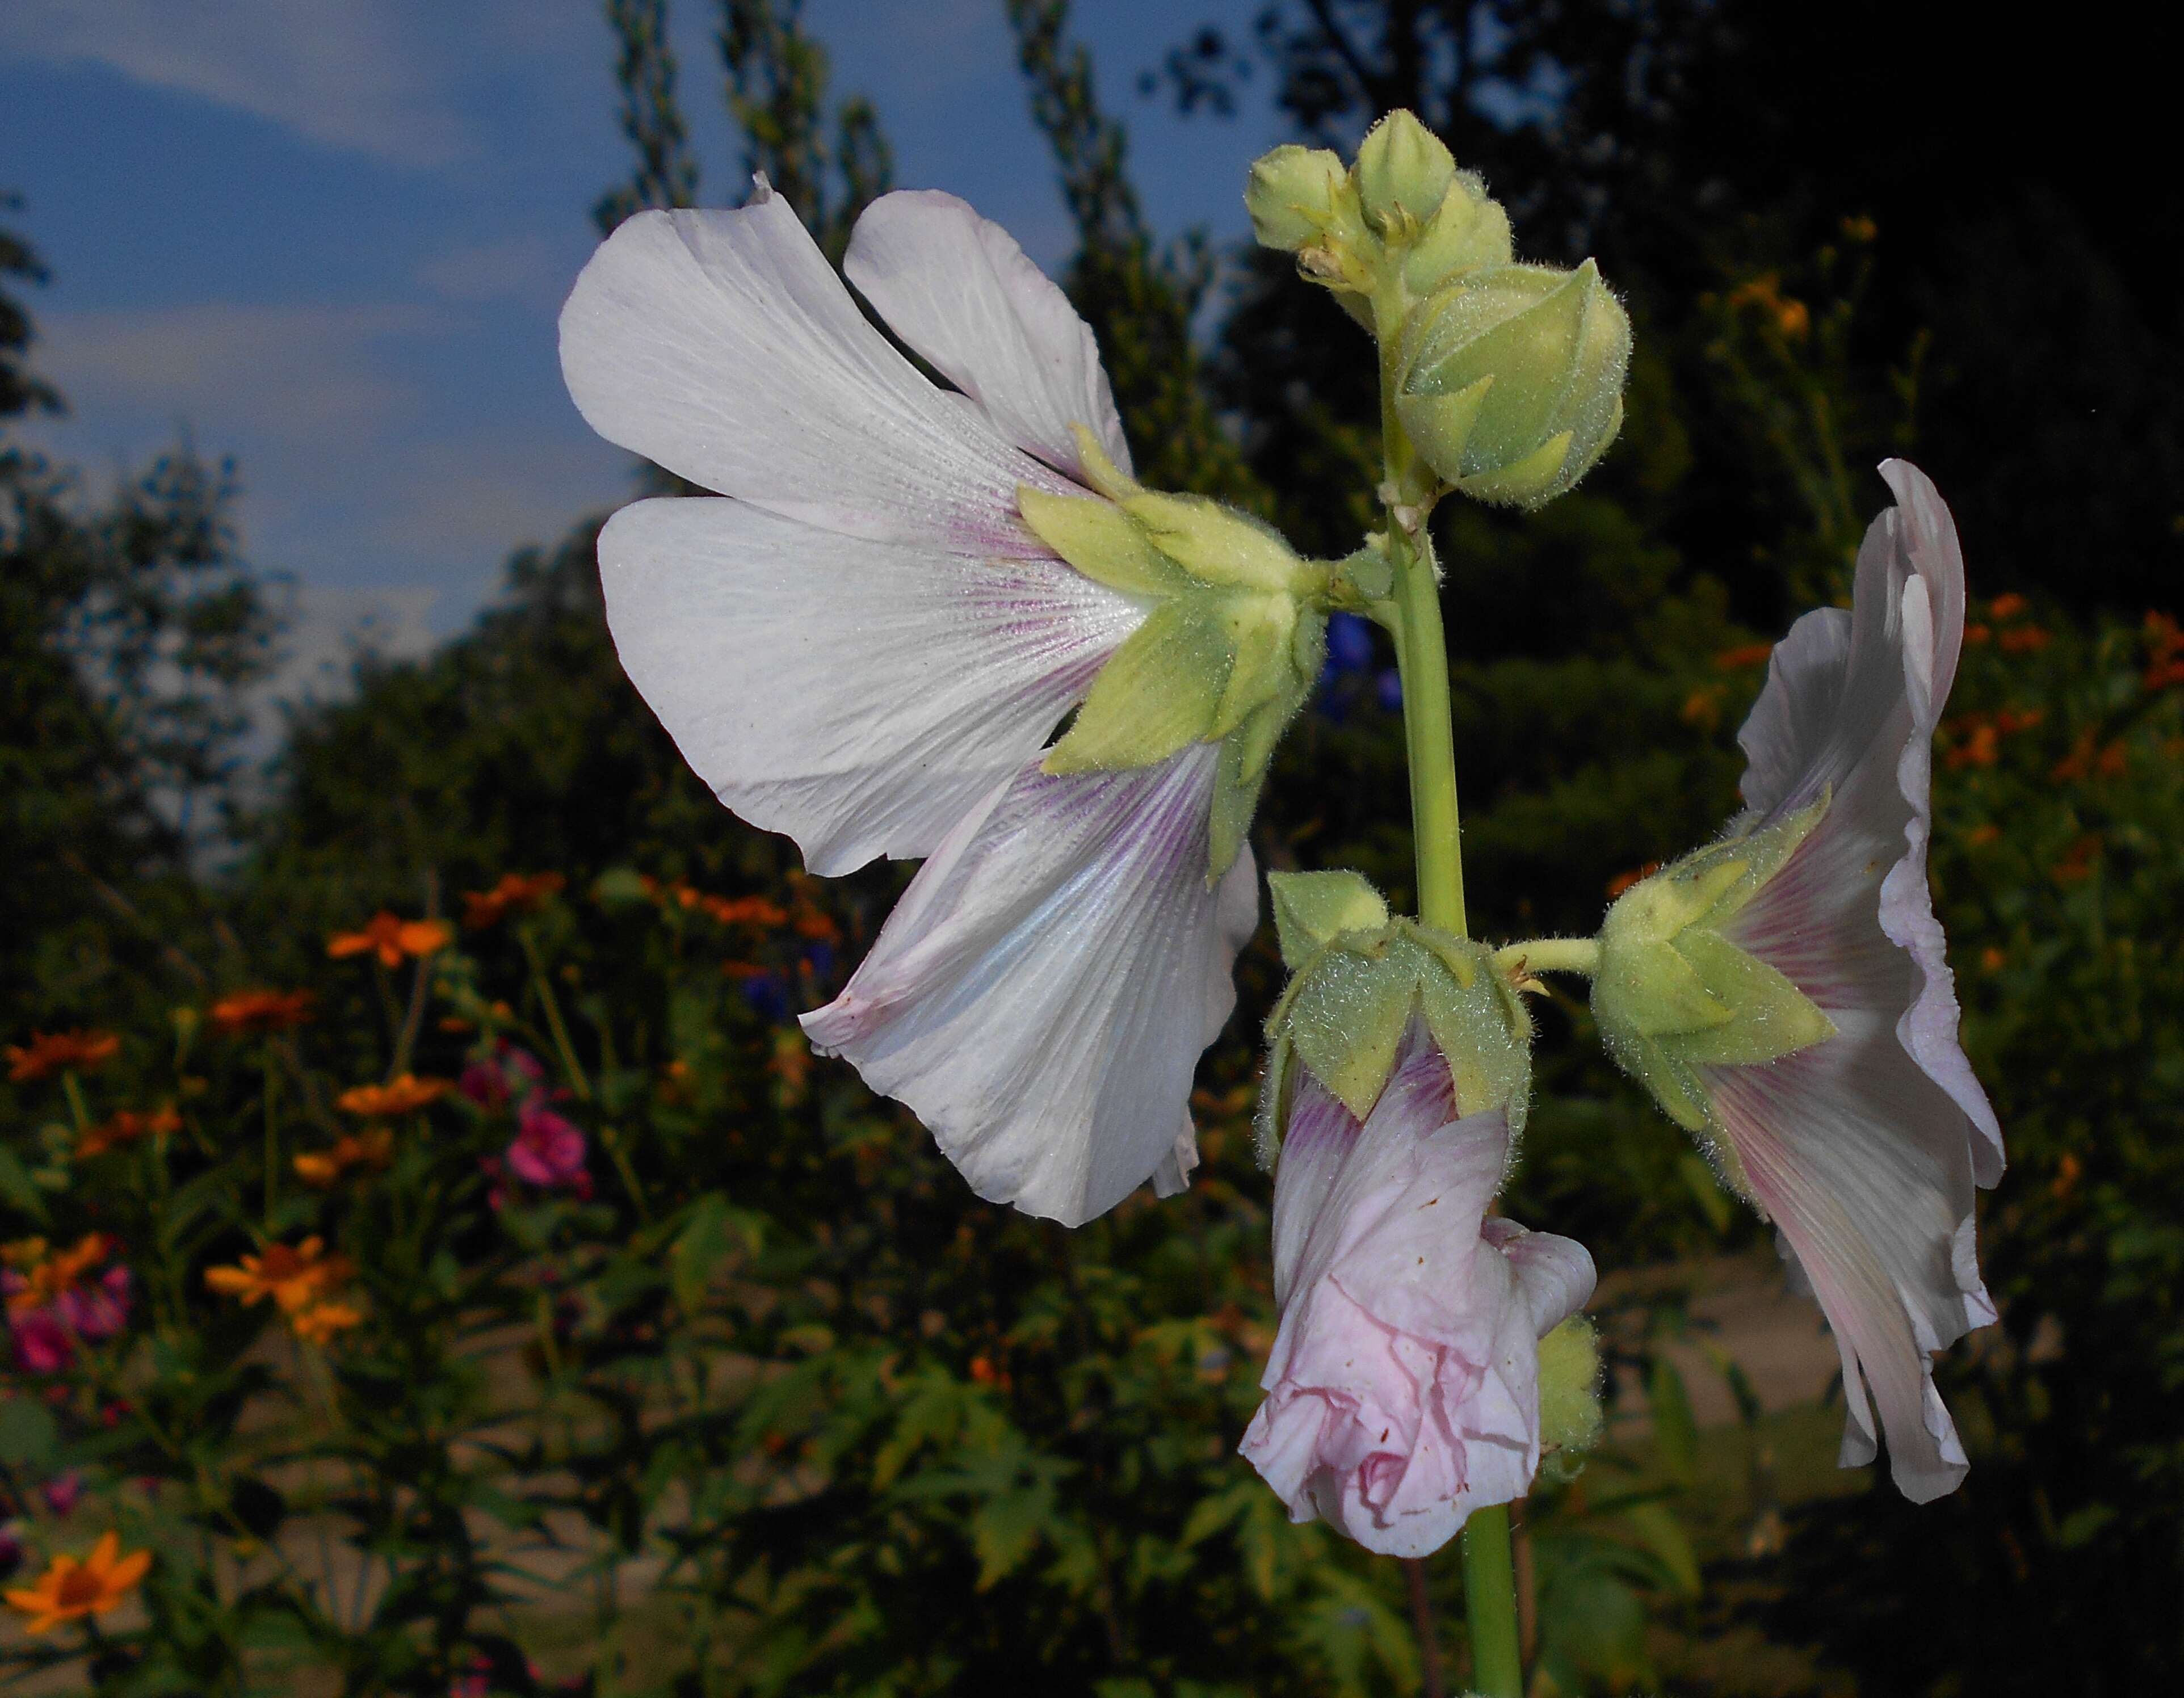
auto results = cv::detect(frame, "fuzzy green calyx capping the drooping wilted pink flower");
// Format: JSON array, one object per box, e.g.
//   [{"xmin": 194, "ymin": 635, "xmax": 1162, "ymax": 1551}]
[{"xmin": 1258, "ymin": 873, "xmax": 1531, "ymax": 1154}]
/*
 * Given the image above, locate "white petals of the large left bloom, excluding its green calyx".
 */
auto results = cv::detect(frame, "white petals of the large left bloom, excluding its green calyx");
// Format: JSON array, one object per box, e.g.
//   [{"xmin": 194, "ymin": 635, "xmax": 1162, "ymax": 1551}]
[{"xmin": 561, "ymin": 181, "xmax": 1258, "ymax": 1222}]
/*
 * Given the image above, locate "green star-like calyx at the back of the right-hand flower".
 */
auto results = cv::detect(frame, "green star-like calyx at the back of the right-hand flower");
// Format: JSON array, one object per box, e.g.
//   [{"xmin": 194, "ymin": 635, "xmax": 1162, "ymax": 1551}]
[{"xmin": 1592, "ymin": 797, "xmax": 1834, "ymax": 1194}]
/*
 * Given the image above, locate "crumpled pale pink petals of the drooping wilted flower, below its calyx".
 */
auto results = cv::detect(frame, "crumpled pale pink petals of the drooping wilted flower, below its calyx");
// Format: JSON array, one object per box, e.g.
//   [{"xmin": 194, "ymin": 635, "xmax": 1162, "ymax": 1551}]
[{"xmin": 1243, "ymin": 1022, "xmax": 1592, "ymax": 1556}]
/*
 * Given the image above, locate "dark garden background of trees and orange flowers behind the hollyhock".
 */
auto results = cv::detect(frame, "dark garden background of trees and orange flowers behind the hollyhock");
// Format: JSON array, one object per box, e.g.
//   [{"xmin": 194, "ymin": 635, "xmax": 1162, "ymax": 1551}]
[{"xmin": 0, "ymin": 0, "xmax": 2184, "ymax": 1698}]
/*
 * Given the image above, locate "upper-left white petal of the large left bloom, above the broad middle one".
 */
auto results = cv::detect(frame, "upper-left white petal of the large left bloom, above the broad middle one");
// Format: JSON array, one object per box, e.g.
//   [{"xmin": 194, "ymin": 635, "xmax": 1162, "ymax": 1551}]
[{"xmin": 561, "ymin": 192, "xmax": 1074, "ymax": 554}]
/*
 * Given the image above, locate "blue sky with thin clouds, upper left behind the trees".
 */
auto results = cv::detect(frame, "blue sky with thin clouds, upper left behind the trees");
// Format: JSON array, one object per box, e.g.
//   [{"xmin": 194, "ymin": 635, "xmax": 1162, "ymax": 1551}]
[{"xmin": 0, "ymin": 0, "xmax": 1280, "ymax": 676}]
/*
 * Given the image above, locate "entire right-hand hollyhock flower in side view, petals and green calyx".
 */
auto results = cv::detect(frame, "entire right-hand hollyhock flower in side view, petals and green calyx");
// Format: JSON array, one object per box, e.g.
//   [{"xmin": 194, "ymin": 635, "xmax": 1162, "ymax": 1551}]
[{"xmin": 1592, "ymin": 460, "xmax": 2003, "ymax": 1502}]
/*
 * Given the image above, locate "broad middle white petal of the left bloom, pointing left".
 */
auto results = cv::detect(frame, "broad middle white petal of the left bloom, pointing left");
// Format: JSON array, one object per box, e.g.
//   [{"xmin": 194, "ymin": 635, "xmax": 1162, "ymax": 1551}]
[{"xmin": 598, "ymin": 486, "xmax": 1144, "ymax": 860}]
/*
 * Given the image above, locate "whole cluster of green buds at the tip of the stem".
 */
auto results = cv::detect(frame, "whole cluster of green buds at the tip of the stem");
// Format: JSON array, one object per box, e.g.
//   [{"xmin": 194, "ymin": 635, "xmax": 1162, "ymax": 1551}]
[{"xmin": 1245, "ymin": 111, "xmax": 1631, "ymax": 506}]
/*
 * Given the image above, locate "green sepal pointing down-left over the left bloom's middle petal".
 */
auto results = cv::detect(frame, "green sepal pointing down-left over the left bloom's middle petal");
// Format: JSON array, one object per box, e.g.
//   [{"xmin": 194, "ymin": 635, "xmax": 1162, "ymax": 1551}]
[{"xmin": 1040, "ymin": 598, "xmax": 1234, "ymax": 772}]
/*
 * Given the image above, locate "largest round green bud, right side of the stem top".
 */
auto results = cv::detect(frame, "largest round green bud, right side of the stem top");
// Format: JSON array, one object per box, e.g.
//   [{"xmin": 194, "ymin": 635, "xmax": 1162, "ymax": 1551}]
[{"xmin": 1396, "ymin": 260, "xmax": 1631, "ymax": 506}]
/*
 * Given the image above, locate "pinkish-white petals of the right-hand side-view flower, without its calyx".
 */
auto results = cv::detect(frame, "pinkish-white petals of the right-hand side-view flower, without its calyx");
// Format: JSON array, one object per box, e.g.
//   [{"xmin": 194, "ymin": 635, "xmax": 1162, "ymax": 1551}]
[{"xmin": 1624, "ymin": 460, "xmax": 2003, "ymax": 1502}]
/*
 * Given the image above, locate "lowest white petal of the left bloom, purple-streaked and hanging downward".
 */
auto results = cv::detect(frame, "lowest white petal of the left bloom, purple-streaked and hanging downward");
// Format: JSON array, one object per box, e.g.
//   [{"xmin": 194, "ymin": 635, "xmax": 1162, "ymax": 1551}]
[{"xmin": 804, "ymin": 744, "xmax": 1234, "ymax": 1226}]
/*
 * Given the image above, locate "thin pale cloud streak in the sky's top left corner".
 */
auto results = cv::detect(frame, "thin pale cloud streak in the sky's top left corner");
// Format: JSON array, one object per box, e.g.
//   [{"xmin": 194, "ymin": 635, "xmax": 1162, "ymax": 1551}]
[{"xmin": 0, "ymin": 0, "xmax": 476, "ymax": 168}]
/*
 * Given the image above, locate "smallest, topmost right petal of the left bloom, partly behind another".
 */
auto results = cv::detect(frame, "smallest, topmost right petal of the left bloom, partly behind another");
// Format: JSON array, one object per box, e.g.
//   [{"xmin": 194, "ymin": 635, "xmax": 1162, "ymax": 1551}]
[{"xmin": 843, "ymin": 190, "xmax": 1129, "ymax": 478}]
